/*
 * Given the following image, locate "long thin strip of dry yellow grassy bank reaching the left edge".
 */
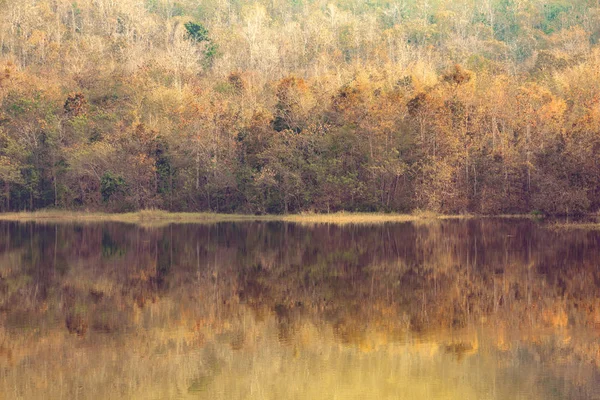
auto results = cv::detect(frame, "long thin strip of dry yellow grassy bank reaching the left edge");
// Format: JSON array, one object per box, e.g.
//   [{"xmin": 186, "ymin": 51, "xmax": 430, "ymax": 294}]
[{"xmin": 0, "ymin": 210, "xmax": 470, "ymax": 225}]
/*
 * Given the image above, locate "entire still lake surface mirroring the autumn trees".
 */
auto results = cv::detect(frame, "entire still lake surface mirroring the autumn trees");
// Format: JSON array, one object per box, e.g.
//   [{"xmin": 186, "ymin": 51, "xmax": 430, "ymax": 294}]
[{"xmin": 0, "ymin": 219, "xmax": 600, "ymax": 400}]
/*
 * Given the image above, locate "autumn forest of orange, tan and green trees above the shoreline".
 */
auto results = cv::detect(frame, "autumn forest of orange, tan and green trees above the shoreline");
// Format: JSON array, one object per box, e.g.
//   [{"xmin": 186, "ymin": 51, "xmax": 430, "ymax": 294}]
[{"xmin": 0, "ymin": 0, "xmax": 600, "ymax": 215}]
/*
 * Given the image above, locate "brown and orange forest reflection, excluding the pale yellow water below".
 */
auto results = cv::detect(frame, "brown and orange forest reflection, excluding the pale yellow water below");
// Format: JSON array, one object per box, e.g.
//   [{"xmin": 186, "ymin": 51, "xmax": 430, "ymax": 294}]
[{"xmin": 0, "ymin": 219, "xmax": 600, "ymax": 398}]
